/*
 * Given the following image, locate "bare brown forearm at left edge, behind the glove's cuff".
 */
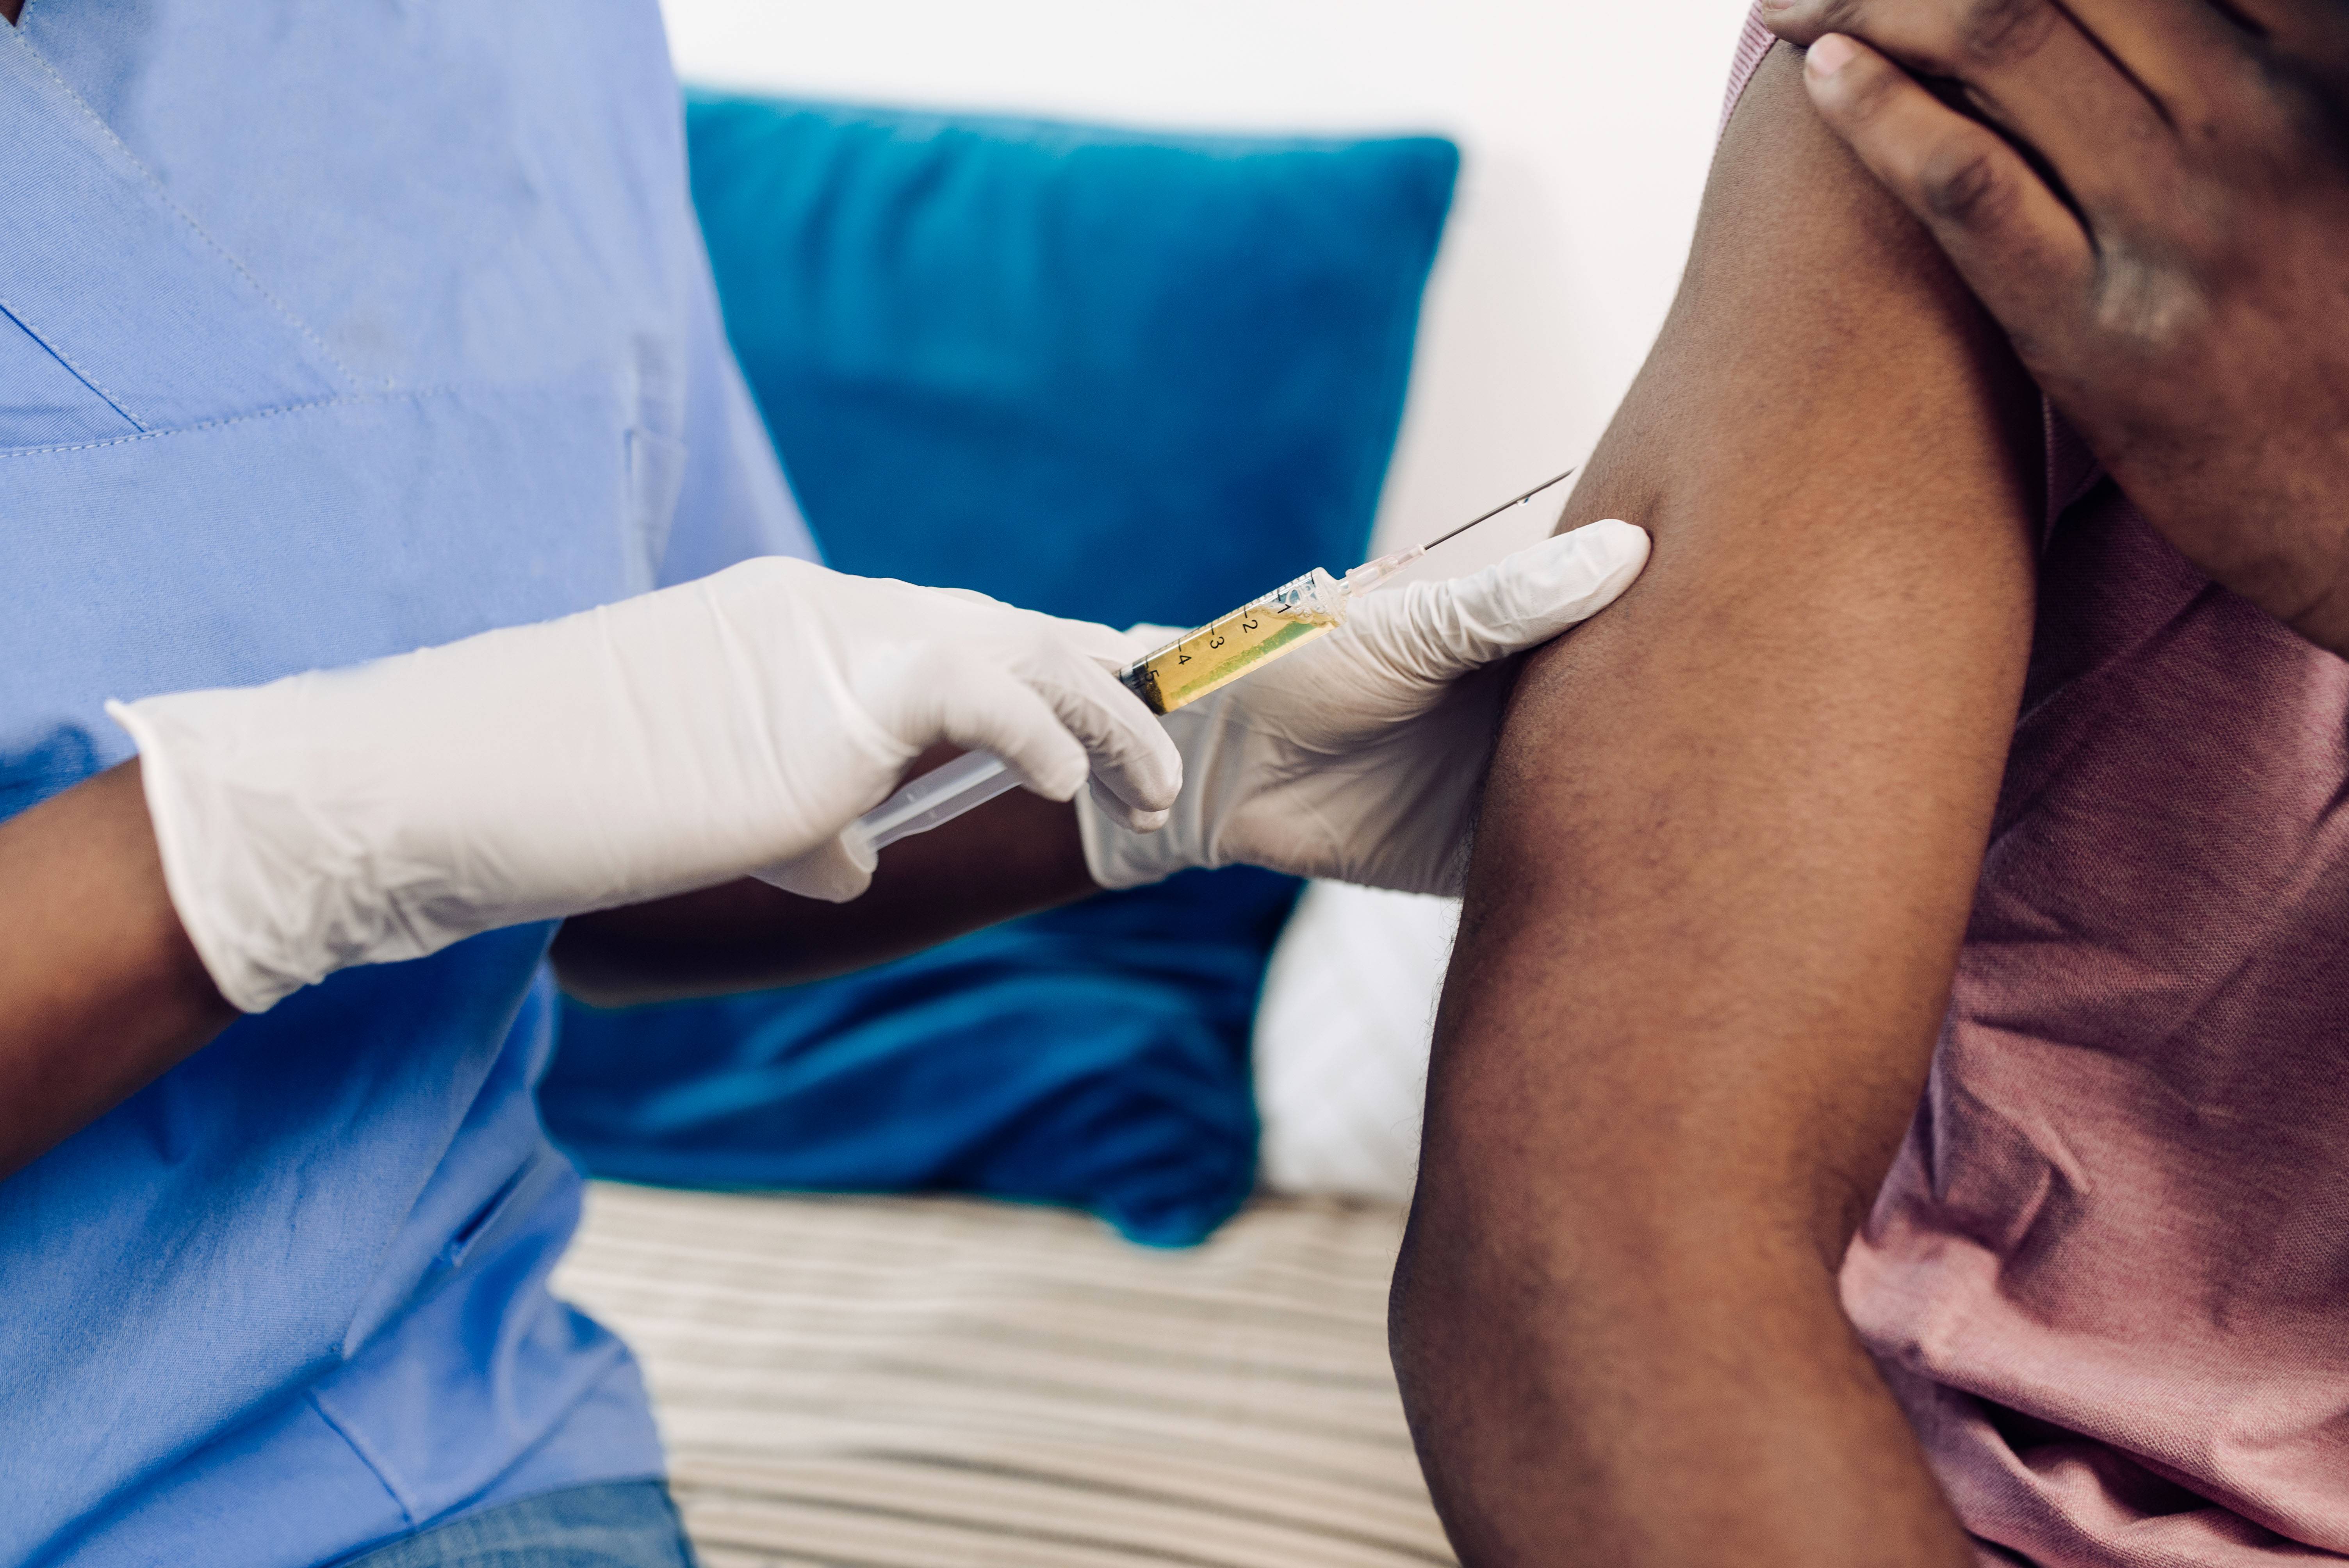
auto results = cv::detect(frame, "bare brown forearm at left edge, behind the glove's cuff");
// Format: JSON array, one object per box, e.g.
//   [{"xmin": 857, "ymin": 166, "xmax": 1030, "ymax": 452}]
[{"xmin": 0, "ymin": 761, "xmax": 237, "ymax": 1176}]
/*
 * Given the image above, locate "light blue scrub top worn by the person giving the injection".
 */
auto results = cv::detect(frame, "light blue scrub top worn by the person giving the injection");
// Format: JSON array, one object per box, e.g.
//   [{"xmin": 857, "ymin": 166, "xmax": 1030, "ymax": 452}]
[{"xmin": 0, "ymin": 0, "xmax": 813, "ymax": 1568}]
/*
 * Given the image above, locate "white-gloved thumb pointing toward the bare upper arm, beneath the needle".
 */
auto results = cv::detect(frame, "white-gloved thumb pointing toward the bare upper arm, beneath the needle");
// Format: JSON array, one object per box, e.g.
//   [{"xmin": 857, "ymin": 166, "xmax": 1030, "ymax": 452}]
[{"xmin": 1355, "ymin": 519, "xmax": 1649, "ymax": 681}]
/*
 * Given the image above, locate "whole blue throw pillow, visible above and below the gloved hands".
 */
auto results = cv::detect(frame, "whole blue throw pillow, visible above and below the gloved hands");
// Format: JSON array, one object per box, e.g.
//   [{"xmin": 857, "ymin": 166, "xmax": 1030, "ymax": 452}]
[{"xmin": 540, "ymin": 94, "xmax": 1459, "ymax": 1244}]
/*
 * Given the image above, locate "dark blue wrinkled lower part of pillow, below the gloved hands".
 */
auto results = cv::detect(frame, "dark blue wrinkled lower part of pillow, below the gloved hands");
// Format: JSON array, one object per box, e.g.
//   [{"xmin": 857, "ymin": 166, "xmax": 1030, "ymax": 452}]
[{"xmin": 547, "ymin": 868, "xmax": 1294, "ymax": 1246}]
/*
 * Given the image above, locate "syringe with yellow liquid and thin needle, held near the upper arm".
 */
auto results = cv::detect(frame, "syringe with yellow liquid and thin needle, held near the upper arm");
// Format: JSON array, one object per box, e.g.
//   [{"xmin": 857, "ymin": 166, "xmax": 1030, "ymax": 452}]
[{"xmin": 848, "ymin": 469, "xmax": 1574, "ymax": 852}]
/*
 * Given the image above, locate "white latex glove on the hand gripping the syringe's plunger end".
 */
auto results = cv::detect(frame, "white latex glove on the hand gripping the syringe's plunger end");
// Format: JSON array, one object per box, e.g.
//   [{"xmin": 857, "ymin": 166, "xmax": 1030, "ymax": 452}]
[{"xmin": 108, "ymin": 559, "xmax": 1182, "ymax": 1012}]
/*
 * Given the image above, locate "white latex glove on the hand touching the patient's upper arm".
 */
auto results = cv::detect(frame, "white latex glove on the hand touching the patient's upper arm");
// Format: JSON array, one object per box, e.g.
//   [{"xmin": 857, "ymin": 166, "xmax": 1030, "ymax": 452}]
[{"xmin": 1078, "ymin": 521, "xmax": 1647, "ymax": 894}]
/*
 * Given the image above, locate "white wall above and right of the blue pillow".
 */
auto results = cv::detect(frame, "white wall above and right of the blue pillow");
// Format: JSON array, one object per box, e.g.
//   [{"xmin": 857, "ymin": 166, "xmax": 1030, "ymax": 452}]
[{"xmin": 665, "ymin": 0, "xmax": 1745, "ymax": 566}]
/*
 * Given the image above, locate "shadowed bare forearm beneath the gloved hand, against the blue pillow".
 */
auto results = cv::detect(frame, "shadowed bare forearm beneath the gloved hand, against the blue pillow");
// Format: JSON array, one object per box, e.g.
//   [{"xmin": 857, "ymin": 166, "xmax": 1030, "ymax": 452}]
[{"xmin": 554, "ymin": 768, "xmax": 1099, "ymax": 1007}]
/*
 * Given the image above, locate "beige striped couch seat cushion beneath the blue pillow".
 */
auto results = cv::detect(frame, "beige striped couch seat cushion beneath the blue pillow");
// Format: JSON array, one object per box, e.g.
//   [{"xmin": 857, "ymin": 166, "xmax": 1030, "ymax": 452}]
[{"xmin": 557, "ymin": 1183, "xmax": 1454, "ymax": 1568}]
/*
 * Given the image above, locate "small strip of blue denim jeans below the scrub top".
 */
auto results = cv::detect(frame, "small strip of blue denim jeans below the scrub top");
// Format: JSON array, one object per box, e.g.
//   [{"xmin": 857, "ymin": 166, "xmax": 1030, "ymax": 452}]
[{"xmin": 336, "ymin": 1481, "xmax": 693, "ymax": 1568}]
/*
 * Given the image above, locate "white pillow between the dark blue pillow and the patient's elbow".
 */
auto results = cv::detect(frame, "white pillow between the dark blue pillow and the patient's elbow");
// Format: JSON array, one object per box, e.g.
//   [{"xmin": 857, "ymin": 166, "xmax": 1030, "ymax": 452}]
[{"xmin": 1255, "ymin": 883, "xmax": 1461, "ymax": 1202}]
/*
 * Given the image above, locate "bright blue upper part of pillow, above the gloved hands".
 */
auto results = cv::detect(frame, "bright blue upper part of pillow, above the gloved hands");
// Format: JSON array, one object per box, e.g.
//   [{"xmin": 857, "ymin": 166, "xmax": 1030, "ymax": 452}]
[{"xmin": 686, "ymin": 94, "xmax": 1459, "ymax": 624}]
